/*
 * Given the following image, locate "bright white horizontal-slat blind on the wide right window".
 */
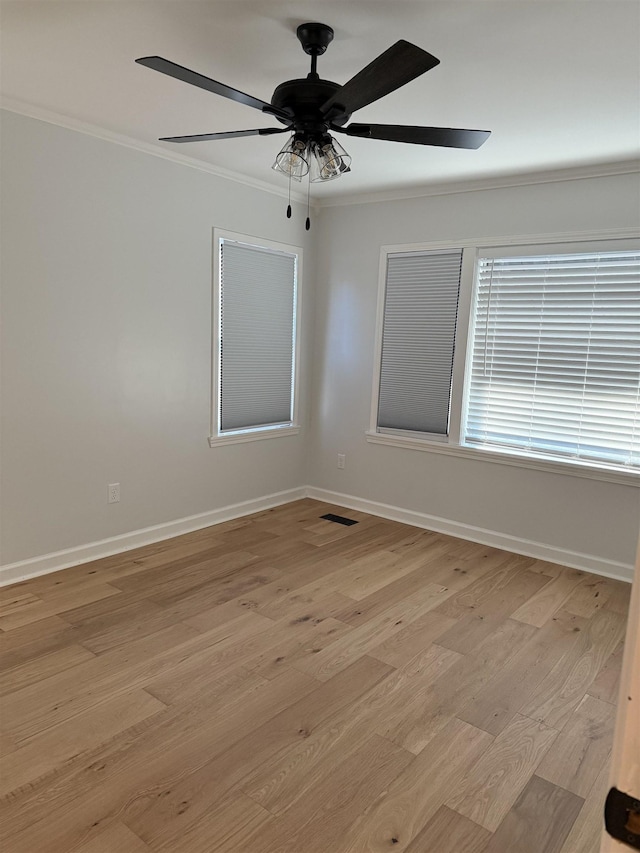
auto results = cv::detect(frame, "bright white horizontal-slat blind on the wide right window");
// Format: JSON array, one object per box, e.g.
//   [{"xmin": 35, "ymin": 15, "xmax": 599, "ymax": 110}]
[{"xmin": 464, "ymin": 246, "xmax": 640, "ymax": 467}]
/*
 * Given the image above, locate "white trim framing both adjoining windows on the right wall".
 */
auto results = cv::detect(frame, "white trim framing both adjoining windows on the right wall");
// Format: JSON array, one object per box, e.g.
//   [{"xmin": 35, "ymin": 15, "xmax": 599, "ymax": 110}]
[{"xmin": 365, "ymin": 228, "xmax": 640, "ymax": 488}]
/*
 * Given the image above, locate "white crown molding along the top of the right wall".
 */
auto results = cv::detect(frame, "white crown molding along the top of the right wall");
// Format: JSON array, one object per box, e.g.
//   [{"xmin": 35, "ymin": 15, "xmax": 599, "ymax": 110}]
[{"xmin": 315, "ymin": 160, "xmax": 640, "ymax": 208}]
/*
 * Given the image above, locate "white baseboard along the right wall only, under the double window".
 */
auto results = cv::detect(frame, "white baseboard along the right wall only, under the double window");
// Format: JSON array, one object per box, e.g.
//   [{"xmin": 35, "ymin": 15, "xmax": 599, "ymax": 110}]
[{"xmin": 306, "ymin": 486, "xmax": 634, "ymax": 582}]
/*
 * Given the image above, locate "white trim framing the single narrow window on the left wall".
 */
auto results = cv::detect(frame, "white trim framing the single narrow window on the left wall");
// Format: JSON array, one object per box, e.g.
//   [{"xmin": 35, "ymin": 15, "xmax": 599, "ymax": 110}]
[{"xmin": 208, "ymin": 227, "xmax": 303, "ymax": 447}]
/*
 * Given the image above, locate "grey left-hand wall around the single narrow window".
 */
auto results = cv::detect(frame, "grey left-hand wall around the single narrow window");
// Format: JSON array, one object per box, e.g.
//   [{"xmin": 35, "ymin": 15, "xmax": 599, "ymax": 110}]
[{"xmin": 1, "ymin": 112, "xmax": 312, "ymax": 564}]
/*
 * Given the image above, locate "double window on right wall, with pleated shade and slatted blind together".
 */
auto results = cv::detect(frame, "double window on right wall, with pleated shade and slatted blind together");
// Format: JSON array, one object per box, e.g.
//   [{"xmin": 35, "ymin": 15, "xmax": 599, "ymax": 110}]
[{"xmin": 367, "ymin": 239, "xmax": 640, "ymax": 483}]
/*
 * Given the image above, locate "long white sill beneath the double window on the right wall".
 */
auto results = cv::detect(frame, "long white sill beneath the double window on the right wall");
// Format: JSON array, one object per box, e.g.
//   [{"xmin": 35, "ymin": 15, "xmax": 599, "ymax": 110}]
[{"xmin": 365, "ymin": 431, "xmax": 640, "ymax": 487}]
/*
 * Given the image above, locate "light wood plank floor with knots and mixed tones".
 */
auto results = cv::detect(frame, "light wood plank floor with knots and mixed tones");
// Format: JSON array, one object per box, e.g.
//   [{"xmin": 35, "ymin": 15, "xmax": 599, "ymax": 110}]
[{"xmin": 0, "ymin": 500, "xmax": 629, "ymax": 853}]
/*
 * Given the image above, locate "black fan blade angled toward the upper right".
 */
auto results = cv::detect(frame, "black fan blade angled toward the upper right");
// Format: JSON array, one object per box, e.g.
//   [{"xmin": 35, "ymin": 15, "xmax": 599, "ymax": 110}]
[{"xmin": 322, "ymin": 39, "xmax": 440, "ymax": 115}]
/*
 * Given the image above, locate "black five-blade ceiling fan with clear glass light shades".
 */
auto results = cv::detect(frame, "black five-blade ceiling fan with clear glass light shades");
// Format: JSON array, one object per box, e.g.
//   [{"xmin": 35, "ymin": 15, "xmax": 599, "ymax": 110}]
[{"xmin": 136, "ymin": 23, "xmax": 490, "ymax": 227}]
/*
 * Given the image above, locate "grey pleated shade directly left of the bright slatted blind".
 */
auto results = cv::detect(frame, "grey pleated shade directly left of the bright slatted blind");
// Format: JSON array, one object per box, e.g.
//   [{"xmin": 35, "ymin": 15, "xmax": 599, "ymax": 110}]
[{"xmin": 378, "ymin": 249, "xmax": 462, "ymax": 436}]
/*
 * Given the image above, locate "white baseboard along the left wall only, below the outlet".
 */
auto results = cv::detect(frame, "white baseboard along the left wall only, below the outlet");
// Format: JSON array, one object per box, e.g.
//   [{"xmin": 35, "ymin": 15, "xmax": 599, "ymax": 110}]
[{"xmin": 0, "ymin": 487, "xmax": 306, "ymax": 586}]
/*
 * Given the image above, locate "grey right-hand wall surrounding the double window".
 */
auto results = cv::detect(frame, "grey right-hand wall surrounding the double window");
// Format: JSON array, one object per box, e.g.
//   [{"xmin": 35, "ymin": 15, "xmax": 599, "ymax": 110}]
[{"xmin": 309, "ymin": 175, "xmax": 640, "ymax": 566}]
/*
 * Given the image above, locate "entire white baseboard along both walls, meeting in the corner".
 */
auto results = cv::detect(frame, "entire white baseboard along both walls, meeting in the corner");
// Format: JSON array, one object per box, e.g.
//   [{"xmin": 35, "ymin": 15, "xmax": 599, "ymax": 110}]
[{"xmin": 0, "ymin": 486, "xmax": 634, "ymax": 586}]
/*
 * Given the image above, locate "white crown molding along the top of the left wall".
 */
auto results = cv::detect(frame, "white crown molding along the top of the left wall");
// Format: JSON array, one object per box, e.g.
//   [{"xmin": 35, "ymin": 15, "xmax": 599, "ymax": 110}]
[{"xmin": 0, "ymin": 96, "xmax": 315, "ymax": 206}]
